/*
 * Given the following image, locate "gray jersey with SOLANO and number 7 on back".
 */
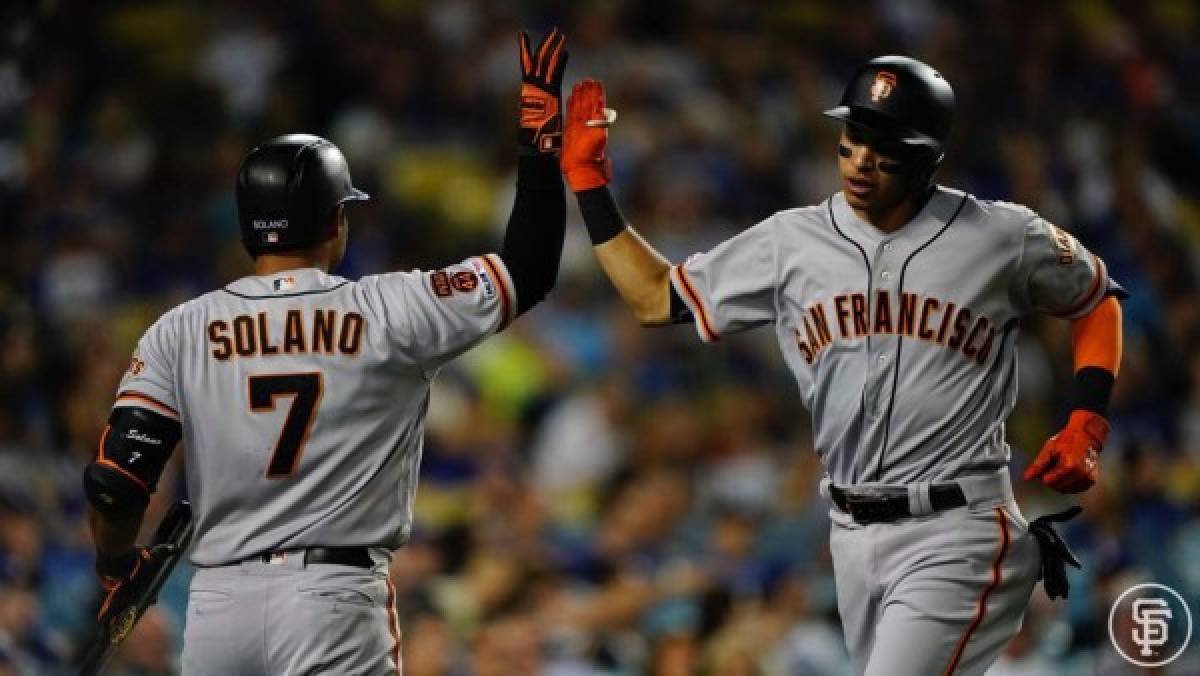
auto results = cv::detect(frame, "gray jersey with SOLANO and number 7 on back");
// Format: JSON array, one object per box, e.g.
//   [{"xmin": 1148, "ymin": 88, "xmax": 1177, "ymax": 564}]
[{"xmin": 108, "ymin": 255, "xmax": 516, "ymax": 566}]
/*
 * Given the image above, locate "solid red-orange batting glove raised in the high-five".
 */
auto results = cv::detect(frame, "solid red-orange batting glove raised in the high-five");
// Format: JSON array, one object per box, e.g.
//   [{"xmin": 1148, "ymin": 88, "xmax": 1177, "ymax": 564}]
[{"xmin": 559, "ymin": 79, "xmax": 617, "ymax": 192}]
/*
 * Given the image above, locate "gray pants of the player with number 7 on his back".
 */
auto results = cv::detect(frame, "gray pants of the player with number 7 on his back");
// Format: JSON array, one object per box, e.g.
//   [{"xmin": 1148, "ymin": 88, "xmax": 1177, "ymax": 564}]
[{"xmin": 182, "ymin": 552, "xmax": 400, "ymax": 676}]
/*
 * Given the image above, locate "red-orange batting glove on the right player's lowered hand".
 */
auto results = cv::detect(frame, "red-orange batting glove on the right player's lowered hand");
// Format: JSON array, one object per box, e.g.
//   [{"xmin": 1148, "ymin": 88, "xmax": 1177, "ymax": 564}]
[{"xmin": 1025, "ymin": 409, "xmax": 1109, "ymax": 493}]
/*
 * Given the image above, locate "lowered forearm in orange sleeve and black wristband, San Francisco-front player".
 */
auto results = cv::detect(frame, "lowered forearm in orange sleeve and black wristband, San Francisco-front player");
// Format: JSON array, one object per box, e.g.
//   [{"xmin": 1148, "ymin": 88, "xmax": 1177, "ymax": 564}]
[{"xmin": 1070, "ymin": 297, "xmax": 1122, "ymax": 415}]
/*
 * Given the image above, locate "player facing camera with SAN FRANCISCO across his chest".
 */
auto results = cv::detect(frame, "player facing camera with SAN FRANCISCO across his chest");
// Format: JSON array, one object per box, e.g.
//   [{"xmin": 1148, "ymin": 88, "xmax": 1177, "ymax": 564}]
[{"xmin": 562, "ymin": 56, "xmax": 1122, "ymax": 676}]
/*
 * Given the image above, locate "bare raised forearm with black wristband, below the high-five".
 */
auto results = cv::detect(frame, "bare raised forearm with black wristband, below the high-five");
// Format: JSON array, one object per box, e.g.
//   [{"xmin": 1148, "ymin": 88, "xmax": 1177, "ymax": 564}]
[{"xmin": 576, "ymin": 186, "xmax": 671, "ymax": 325}]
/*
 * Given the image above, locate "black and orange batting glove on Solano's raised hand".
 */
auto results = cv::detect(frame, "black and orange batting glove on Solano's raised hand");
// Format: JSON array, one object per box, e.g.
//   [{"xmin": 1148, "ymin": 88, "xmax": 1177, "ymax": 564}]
[{"xmin": 517, "ymin": 28, "xmax": 566, "ymax": 154}]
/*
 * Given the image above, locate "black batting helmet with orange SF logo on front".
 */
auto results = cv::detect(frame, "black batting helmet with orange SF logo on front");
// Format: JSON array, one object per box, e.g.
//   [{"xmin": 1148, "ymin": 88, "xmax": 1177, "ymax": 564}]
[{"xmin": 824, "ymin": 56, "xmax": 954, "ymax": 163}]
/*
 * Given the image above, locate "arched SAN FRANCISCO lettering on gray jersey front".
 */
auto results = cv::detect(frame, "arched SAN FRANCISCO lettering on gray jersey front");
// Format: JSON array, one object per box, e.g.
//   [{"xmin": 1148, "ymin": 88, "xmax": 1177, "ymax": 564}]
[{"xmin": 793, "ymin": 289, "xmax": 996, "ymax": 365}]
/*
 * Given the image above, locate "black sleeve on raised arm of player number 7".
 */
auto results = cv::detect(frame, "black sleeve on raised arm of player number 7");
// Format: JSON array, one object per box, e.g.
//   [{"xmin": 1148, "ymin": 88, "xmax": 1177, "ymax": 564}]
[{"xmin": 500, "ymin": 155, "xmax": 566, "ymax": 315}]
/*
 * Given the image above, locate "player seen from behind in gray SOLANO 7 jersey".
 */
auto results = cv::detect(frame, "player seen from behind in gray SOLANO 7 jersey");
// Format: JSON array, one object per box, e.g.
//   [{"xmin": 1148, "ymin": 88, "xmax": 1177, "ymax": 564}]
[{"xmin": 84, "ymin": 29, "xmax": 566, "ymax": 676}]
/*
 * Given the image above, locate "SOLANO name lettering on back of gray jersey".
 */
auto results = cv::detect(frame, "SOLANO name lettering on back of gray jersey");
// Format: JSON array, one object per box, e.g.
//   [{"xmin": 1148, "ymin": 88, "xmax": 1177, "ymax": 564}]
[{"xmin": 208, "ymin": 309, "xmax": 366, "ymax": 361}]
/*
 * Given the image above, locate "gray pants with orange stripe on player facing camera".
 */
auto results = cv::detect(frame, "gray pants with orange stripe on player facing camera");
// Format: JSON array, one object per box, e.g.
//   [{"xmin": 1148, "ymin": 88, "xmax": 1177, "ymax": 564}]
[{"xmin": 829, "ymin": 471, "xmax": 1040, "ymax": 676}]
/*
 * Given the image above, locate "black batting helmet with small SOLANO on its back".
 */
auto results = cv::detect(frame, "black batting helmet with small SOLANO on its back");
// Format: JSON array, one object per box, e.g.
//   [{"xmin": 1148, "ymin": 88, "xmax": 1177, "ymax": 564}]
[{"xmin": 238, "ymin": 133, "xmax": 368, "ymax": 256}]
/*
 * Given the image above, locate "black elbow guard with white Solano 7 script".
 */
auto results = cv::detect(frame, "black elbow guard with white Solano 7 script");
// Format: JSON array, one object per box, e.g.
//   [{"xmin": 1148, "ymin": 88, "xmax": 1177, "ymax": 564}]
[{"xmin": 83, "ymin": 407, "xmax": 182, "ymax": 516}]
